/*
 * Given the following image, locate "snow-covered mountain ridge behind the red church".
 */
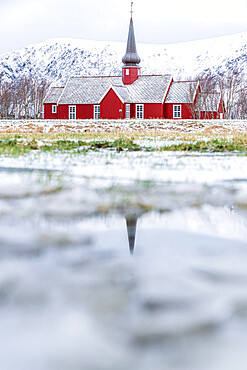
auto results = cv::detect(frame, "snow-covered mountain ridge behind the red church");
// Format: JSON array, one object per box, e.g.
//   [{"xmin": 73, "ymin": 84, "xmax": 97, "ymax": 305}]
[{"xmin": 0, "ymin": 32, "xmax": 247, "ymax": 85}]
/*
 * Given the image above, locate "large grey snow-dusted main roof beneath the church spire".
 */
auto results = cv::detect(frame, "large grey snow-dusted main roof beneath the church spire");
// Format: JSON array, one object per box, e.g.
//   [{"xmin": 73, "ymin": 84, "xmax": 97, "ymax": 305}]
[{"xmin": 55, "ymin": 75, "xmax": 171, "ymax": 105}]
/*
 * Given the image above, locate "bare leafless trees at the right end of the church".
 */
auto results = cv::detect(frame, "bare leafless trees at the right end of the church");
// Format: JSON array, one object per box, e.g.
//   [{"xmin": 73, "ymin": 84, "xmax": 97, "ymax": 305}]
[{"xmin": 188, "ymin": 69, "xmax": 247, "ymax": 119}]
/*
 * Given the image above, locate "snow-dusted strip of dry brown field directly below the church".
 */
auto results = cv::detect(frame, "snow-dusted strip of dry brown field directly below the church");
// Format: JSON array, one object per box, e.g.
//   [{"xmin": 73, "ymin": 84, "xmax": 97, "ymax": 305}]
[{"xmin": 0, "ymin": 119, "xmax": 247, "ymax": 133}]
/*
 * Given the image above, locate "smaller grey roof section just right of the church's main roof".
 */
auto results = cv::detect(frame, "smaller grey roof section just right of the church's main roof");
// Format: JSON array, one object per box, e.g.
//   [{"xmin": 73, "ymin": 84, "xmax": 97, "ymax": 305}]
[{"xmin": 166, "ymin": 81, "xmax": 198, "ymax": 104}]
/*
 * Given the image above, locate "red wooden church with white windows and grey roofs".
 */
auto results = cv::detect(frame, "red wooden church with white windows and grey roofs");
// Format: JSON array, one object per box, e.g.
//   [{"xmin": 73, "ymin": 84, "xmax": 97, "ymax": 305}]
[{"xmin": 44, "ymin": 15, "xmax": 224, "ymax": 120}]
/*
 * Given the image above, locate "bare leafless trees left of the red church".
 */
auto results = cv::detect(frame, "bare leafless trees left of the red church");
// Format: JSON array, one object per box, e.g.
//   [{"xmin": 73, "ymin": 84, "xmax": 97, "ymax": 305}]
[{"xmin": 0, "ymin": 74, "xmax": 50, "ymax": 119}]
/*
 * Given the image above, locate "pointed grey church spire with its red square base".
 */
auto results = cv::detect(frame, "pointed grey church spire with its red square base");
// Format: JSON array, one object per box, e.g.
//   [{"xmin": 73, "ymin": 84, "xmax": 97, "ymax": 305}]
[{"xmin": 122, "ymin": 2, "xmax": 141, "ymax": 85}]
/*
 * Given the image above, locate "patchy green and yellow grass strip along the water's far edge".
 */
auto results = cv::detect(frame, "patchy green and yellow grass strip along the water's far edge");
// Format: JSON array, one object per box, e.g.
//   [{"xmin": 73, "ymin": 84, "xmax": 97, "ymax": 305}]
[{"xmin": 0, "ymin": 131, "xmax": 247, "ymax": 156}]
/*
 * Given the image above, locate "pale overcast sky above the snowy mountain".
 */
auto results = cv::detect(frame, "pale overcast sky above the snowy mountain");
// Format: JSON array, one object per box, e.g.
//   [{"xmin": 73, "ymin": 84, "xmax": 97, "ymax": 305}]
[{"xmin": 0, "ymin": 0, "xmax": 247, "ymax": 54}]
